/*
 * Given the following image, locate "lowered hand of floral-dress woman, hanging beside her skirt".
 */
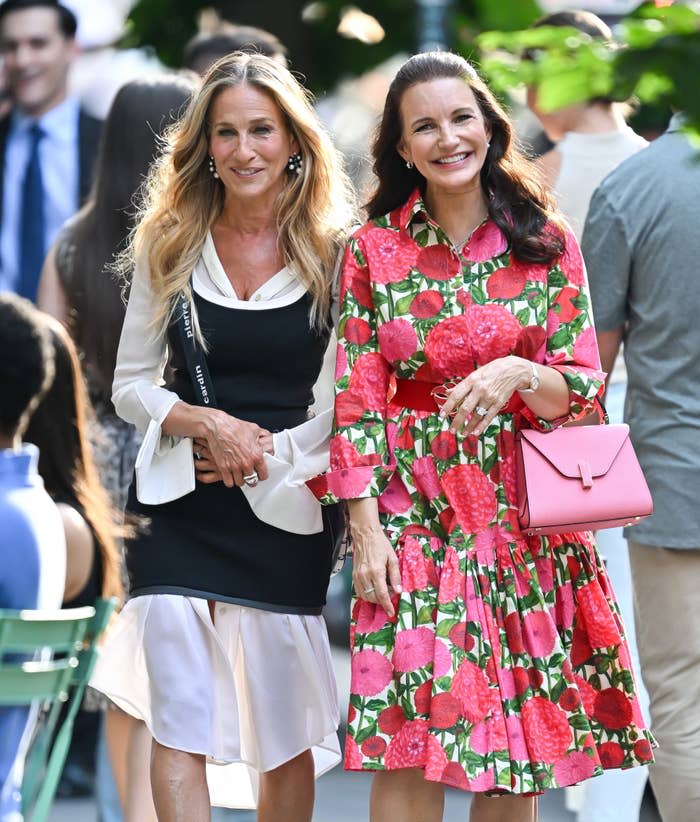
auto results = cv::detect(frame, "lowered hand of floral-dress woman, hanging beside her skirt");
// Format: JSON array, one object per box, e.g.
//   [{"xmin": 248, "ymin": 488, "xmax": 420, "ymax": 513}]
[{"xmin": 348, "ymin": 499, "xmax": 401, "ymax": 616}]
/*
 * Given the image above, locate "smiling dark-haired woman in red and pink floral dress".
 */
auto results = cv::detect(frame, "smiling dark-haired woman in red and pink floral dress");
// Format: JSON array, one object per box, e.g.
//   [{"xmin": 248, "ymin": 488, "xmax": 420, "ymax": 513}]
[{"xmin": 308, "ymin": 52, "xmax": 654, "ymax": 822}]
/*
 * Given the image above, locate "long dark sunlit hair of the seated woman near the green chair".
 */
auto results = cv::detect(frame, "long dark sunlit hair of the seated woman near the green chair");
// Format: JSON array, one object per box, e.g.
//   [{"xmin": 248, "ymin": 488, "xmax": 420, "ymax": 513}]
[{"xmin": 23, "ymin": 316, "xmax": 130, "ymax": 599}]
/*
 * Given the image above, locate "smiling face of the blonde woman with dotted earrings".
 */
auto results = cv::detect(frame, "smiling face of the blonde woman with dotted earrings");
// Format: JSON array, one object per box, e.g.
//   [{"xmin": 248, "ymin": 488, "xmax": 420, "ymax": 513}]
[{"xmin": 209, "ymin": 83, "xmax": 299, "ymax": 208}]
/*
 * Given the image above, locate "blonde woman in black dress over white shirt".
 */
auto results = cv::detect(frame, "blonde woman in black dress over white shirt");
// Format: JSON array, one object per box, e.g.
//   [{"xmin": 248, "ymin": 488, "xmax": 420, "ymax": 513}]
[{"xmin": 95, "ymin": 53, "xmax": 351, "ymax": 822}]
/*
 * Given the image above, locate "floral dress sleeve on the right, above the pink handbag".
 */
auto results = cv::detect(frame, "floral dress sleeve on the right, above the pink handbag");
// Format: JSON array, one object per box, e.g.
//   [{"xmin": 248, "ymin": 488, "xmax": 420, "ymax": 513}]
[{"xmin": 521, "ymin": 225, "xmax": 606, "ymax": 431}]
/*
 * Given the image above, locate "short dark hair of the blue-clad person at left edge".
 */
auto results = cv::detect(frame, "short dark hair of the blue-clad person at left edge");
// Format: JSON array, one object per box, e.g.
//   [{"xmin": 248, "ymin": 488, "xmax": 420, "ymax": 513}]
[{"xmin": 0, "ymin": 294, "xmax": 54, "ymax": 437}]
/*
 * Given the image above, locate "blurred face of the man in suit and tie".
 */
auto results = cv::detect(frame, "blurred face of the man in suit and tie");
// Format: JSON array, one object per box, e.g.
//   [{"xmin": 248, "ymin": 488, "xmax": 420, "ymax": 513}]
[{"xmin": 0, "ymin": 6, "xmax": 76, "ymax": 117}]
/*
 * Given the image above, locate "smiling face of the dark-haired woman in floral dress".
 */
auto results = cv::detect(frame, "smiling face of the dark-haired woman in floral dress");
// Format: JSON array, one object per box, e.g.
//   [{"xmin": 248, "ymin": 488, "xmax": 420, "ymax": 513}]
[{"xmin": 397, "ymin": 77, "xmax": 490, "ymax": 200}]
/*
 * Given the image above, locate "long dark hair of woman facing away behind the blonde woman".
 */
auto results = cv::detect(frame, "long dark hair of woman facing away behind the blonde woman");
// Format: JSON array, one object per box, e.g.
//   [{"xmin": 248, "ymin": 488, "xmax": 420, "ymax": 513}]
[{"xmin": 56, "ymin": 74, "xmax": 196, "ymax": 402}]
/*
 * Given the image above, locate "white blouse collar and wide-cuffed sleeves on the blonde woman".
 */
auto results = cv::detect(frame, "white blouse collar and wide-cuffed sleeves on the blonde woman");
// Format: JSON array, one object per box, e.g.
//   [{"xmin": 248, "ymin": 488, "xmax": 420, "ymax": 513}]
[{"xmin": 112, "ymin": 233, "xmax": 335, "ymax": 533}]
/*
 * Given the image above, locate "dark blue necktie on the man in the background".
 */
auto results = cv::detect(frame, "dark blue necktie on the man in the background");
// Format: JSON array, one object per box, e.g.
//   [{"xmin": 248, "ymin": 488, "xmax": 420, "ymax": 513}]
[{"xmin": 17, "ymin": 123, "xmax": 46, "ymax": 300}]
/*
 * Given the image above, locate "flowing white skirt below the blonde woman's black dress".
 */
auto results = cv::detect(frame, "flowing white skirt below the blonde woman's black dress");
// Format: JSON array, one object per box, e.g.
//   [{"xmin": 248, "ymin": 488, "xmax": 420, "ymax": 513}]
[{"xmin": 90, "ymin": 594, "xmax": 341, "ymax": 808}]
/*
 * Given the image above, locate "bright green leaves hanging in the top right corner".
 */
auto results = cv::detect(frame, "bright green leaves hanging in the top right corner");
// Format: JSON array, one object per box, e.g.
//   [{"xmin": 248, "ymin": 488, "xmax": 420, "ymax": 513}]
[{"xmin": 477, "ymin": 3, "xmax": 700, "ymax": 135}]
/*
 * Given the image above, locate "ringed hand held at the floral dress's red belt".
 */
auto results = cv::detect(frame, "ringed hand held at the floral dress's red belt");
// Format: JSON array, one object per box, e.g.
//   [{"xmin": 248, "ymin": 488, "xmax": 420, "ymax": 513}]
[{"xmin": 440, "ymin": 356, "xmax": 532, "ymax": 436}]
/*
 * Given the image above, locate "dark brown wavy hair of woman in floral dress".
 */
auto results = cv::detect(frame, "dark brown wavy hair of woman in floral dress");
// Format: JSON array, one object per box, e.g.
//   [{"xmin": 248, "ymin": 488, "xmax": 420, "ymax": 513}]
[{"xmin": 365, "ymin": 51, "xmax": 564, "ymax": 263}]
